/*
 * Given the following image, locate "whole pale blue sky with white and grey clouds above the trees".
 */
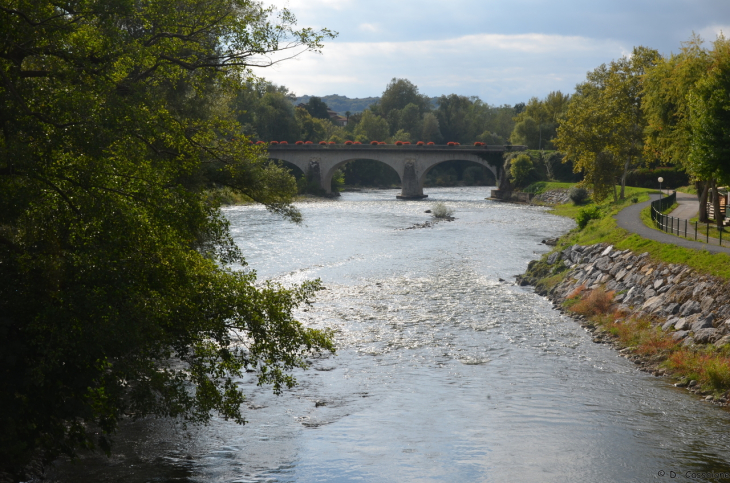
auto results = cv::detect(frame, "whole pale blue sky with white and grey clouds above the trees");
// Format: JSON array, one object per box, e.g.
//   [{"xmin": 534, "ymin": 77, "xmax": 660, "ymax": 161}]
[{"xmin": 254, "ymin": 0, "xmax": 730, "ymax": 105}]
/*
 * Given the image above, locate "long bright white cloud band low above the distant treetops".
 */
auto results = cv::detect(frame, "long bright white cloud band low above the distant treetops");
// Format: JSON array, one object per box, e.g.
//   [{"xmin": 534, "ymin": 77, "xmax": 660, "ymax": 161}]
[{"xmin": 256, "ymin": 33, "xmax": 631, "ymax": 104}]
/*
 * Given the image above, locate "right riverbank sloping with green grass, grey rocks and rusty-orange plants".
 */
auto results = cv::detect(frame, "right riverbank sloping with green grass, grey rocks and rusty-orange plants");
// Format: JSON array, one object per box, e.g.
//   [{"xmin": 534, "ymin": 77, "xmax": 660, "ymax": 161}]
[{"xmin": 518, "ymin": 191, "xmax": 730, "ymax": 405}]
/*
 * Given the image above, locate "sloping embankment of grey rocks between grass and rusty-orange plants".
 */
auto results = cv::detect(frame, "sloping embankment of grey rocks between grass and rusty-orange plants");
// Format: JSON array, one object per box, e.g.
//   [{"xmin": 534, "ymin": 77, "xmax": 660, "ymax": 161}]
[{"xmin": 518, "ymin": 243, "xmax": 730, "ymax": 347}]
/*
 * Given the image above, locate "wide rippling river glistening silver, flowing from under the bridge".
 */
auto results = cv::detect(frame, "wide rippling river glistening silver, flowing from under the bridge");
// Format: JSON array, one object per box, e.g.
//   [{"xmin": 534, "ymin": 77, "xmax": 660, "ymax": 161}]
[{"xmin": 51, "ymin": 188, "xmax": 730, "ymax": 483}]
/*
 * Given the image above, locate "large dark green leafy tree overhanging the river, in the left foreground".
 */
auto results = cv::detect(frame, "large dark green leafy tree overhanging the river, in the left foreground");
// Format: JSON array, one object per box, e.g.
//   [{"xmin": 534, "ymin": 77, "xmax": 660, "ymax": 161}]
[{"xmin": 0, "ymin": 0, "xmax": 333, "ymax": 477}]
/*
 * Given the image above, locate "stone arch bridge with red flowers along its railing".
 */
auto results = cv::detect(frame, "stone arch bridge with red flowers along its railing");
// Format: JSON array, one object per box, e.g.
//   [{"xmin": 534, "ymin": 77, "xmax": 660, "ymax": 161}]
[{"xmin": 269, "ymin": 144, "xmax": 526, "ymax": 199}]
